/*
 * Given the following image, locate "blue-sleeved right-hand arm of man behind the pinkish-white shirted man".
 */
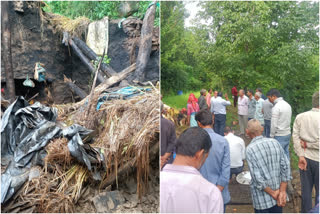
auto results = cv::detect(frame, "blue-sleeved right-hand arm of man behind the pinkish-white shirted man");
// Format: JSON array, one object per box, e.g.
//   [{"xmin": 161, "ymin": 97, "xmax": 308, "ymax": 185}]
[{"xmin": 217, "ymin": 139, "xmax": 230, "ymax": 192}]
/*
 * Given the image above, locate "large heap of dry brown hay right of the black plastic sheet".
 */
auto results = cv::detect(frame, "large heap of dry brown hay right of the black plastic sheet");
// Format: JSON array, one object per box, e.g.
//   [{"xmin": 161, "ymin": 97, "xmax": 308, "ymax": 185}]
[{"xmin": 55, "ymin": 84, "xmax": 160, "ymax": 196}]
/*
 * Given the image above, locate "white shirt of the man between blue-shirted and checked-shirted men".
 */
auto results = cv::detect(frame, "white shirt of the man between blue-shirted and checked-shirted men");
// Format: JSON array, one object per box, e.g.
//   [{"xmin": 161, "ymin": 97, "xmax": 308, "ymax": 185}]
[{"xmin": 224, "ymin": 133, "xmax": 246, "ymax": 168}]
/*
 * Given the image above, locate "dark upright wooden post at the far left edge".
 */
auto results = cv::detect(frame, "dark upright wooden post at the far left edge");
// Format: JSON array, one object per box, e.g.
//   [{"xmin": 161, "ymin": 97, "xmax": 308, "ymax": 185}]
[{"xmin": 1, "ymin": 1, "xmax": 16, "ymax": 102}]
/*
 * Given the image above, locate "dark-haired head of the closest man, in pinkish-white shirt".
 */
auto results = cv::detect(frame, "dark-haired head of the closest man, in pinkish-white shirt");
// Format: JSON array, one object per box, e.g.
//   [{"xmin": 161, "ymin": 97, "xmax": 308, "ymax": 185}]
[{"xmin": 173, "ymin": 127, "xmax": 212, "ymax": 169}]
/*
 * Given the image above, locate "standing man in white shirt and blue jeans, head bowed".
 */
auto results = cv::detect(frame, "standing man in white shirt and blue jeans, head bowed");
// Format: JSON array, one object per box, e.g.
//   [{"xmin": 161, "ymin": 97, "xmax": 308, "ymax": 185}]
[{"xmin": 267, "ymin": 89, "xmax": 292, "ymax": 159}]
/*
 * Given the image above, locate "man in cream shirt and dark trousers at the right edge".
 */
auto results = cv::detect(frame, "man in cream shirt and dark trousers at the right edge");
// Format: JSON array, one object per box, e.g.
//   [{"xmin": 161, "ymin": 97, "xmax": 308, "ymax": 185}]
[{"xmin": 292, "ymin": 91, "xmax": 320, "ymax": 213}]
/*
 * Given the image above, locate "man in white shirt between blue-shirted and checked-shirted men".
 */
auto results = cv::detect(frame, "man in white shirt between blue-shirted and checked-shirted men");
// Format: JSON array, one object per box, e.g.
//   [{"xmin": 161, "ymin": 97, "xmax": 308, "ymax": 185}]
[{"xmin": 224, "ymin": 126, "xmax": 246, "ymax": 180}]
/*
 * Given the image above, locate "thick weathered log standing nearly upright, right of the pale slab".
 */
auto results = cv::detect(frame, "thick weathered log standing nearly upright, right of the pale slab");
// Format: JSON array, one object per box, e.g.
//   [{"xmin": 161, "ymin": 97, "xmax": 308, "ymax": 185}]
[{"xmin": 135, "ymin": 4, "xmax": 156, "ymax": 82}]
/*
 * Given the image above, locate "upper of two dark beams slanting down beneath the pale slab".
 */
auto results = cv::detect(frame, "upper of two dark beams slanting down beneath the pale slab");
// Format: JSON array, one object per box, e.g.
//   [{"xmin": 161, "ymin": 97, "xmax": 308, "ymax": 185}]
[{"xmin": 73, "ymin": 37, "xmax": 116, "ymax": 77}]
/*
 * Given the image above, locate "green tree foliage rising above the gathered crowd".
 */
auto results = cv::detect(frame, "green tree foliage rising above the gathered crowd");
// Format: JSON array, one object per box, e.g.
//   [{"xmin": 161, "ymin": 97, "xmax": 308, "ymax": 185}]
[{"xmin": 161, "ymin": 1, "xmax": 319, "ymax": 116}]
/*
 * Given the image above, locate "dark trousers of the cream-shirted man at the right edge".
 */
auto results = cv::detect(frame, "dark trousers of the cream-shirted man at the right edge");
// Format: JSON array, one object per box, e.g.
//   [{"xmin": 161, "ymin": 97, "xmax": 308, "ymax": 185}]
[{"xmin": 300, "ymin": 158, "xmax": 319, "ymax": 213}]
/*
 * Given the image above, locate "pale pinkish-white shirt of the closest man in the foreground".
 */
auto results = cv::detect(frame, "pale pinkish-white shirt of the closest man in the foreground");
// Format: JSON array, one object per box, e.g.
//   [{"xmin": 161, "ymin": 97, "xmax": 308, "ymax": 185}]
[{"xmin": 160, "ymin": 164, "xmax": 223, "ymax": 213}]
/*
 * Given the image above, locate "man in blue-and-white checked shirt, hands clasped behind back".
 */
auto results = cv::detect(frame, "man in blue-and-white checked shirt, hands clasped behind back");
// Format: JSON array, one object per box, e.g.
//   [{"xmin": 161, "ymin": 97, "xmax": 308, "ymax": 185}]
[{"xmin": 246, "ymin": 119, "xmax": 291, "ymax": 213}]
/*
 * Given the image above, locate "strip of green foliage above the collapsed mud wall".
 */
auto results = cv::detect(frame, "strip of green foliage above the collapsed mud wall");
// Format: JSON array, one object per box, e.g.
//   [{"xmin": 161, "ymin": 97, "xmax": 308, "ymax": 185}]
[{"xmin": 43, "ymin": 1, "xmax": 160, "ymax": 26}]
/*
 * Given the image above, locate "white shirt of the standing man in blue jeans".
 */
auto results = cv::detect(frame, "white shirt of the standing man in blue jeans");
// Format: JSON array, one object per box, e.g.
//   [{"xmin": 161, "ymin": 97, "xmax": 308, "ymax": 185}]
[{"xmin": 270, "ymin": 97, "xmax": 292, "ymax": 137}]
